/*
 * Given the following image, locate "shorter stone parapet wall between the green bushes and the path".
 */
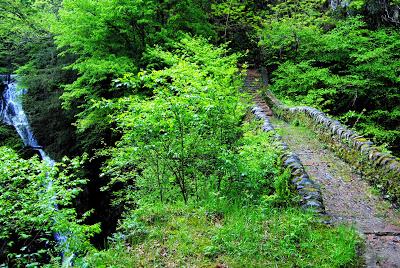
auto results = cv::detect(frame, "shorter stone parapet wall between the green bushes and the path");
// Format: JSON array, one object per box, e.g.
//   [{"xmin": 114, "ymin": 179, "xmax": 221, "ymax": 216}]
[{"xmin": 252, "ymin": 106, "xmax": 325, "ymax": 213}]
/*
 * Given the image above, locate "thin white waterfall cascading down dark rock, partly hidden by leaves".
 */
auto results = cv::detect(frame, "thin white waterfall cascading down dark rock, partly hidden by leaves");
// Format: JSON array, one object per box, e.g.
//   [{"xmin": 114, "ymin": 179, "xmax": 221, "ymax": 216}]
[{"xmin": 0, "ymin": 75, "xmax": 73, "ymax": 267}]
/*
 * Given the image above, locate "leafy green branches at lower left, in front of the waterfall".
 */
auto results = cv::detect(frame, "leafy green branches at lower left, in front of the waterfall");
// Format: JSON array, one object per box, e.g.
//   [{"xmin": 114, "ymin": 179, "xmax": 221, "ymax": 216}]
[{"xmin": 0, "ymin": 147, "xmax": 98, "ymax": 267}]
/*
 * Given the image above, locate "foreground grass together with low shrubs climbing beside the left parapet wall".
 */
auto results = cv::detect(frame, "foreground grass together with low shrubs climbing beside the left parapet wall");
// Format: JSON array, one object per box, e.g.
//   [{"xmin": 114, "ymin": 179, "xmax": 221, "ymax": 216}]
[{"xmin": 80, "ymin": 124, "xmax": 360, "ymax": 267}]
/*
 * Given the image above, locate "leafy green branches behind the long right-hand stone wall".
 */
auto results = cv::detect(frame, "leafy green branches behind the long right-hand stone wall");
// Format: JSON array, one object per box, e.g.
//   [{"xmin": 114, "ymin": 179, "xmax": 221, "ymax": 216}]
[{"xmin": 260, "ymin": 14, "xmax": 400, "ymax": 154}]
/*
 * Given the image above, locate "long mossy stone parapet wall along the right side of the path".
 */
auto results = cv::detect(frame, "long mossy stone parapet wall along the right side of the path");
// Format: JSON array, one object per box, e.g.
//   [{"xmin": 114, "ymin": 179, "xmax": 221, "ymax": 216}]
[{"xmin": 263, "ymin": 91, "xmax": 400, "ymax": 204}]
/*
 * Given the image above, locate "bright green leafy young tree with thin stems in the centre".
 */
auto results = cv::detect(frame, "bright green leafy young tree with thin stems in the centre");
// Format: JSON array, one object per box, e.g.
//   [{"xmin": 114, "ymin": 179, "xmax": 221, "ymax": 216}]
[{"xmin": 97, "ymin": 38, "xmax": 246, "ymax": 205}]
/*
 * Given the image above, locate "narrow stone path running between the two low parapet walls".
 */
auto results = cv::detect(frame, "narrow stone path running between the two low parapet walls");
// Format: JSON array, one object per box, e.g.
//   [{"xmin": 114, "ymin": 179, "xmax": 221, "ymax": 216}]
[{"xmin": 246, "ymin": 71, "xmax": 400, "ymax": 267}]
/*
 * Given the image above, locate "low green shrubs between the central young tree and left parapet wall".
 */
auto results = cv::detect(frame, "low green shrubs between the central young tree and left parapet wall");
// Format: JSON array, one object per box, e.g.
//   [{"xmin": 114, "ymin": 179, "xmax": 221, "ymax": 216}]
[{"xmin": 221, "ymin": 122, "xmax": 293, "ymax": 205}]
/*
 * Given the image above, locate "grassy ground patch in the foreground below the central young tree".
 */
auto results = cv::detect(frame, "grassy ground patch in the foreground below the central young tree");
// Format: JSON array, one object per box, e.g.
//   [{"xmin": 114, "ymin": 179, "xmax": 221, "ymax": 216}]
[{"xmin": 85, "ymin": 202, "xmax": 360, "ymax": 267}]
